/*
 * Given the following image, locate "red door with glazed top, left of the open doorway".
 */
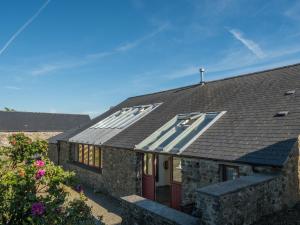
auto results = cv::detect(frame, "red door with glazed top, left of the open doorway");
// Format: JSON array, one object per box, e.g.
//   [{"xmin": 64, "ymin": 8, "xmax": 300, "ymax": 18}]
[{"xmin": 142, "ymin": 153, "xmax": 155, "ymax": 201}]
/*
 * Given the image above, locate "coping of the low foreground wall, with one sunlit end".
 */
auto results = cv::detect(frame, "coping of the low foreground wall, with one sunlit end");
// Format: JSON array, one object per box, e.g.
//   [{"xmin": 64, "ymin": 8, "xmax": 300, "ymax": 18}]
[{"xmin": 121, "ymin": 195, "xmax": 199, "ymax": 225}]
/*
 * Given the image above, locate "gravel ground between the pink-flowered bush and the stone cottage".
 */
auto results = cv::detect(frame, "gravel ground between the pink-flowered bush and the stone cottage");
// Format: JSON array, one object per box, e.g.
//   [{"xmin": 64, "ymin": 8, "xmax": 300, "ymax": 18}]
[{"xmin": 66, "ymin": 187, "xmax": 122, "ymax": 225}]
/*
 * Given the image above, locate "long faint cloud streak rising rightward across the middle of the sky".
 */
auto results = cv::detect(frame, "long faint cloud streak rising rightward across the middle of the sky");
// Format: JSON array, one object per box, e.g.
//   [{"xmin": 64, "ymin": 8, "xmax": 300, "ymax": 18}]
[{"xmin": 30, "ymin": 23, "xmax": 169, "ymax": 76}]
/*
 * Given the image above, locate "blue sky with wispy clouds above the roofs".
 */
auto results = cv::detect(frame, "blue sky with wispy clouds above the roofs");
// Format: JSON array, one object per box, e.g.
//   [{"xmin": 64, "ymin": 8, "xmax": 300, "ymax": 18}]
[{"xmin": 0, "ymin": 0, "xmax": 300, "ymax": 116}]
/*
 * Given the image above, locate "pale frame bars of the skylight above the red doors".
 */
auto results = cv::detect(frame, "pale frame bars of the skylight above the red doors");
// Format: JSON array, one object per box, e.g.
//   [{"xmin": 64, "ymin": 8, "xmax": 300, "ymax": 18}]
[{"xmin": 135, "ymin": 111, "xmax": 226, "ymax": 155}]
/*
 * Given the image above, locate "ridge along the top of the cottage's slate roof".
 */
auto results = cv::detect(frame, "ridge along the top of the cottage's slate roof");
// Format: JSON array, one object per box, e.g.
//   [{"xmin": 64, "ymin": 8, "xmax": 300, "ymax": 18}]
[{"xmin": 128, "ymin": 63, "xmax": 300, "ymax": 99}]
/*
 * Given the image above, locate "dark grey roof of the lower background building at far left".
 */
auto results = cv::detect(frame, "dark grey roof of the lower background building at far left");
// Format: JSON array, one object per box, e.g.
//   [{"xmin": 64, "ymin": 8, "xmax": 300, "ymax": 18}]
[{"xmin": 0, "ymin": 111, "xmax": 91, "ymax": 132}]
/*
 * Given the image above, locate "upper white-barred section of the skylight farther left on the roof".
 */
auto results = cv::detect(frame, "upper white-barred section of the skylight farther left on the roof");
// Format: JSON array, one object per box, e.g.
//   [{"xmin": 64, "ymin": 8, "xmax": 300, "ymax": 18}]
[{"xmin": 90, "ymin": 104, "xmax": 160, "ymax": 129}]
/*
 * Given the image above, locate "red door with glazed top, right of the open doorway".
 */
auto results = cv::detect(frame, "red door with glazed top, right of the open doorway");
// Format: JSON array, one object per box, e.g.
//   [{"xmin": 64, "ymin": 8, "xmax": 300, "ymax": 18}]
[{"xmin": 170, "ymin": 157, "xmax": 182, "ymax": 210}]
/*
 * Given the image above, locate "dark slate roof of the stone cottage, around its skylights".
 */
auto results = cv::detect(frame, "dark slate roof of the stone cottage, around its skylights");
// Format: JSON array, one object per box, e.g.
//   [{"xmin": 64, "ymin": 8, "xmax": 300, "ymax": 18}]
[{"xmin": 62, "ymin": 64, "xmax": 300, "ymax": 166}]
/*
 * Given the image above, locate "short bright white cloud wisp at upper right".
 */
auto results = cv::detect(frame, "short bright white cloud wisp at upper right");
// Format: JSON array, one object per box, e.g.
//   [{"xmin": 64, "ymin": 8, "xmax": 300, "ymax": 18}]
[{"xmin": 229, "ymin": 29, "xmax": 265, "ymax": 58}]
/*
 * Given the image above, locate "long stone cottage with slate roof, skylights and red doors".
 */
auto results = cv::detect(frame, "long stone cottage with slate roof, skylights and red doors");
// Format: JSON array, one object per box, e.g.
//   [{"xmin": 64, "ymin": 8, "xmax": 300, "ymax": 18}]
[{"xmin": 49, "ymin": 64, "xmax": 300, "ymax": 225}]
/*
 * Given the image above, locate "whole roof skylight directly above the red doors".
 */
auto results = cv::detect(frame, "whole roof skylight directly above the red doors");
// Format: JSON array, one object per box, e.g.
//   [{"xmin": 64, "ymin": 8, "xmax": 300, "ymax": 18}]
[{"xmin": 136, "ymin": 111, "xmax": 225, "ymax": 154}]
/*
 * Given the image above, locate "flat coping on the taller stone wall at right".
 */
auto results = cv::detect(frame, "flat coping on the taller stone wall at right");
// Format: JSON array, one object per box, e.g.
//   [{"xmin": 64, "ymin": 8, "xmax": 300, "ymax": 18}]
[{"xmin": 197, "ymin": 174, "xmax": 278, "ymax": 197}]
